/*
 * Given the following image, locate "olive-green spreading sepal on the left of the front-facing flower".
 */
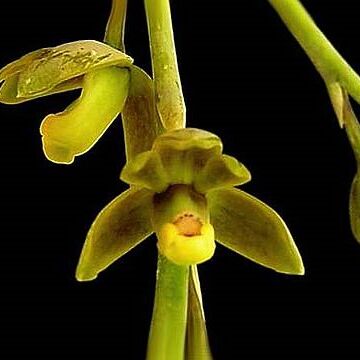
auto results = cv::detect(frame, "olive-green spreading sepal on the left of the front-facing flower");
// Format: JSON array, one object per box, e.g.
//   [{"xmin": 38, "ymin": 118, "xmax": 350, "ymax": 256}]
[{"xmin": 76, "ymin": 189, "xmax": 153, "ymax": 281}]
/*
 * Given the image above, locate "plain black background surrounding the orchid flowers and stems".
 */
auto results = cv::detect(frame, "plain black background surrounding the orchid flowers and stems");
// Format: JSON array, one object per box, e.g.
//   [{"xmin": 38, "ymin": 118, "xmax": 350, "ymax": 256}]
[{"xmin": 0, "ymin": 0, "xmax": 360, "ymax": 360}]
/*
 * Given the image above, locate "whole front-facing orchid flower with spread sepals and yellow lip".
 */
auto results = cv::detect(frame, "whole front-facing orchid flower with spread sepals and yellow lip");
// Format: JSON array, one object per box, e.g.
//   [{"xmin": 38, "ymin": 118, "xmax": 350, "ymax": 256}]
[{"xmin": 76, "ymin": 128, "xmax": 304, "ymax": 281}]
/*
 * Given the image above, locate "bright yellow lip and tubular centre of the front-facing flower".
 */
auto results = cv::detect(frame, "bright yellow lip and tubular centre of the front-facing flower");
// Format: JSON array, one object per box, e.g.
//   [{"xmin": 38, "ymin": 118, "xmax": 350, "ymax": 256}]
[{"xmin": 152, "ymin": 185, "xmax": 216, "ymax": 265}]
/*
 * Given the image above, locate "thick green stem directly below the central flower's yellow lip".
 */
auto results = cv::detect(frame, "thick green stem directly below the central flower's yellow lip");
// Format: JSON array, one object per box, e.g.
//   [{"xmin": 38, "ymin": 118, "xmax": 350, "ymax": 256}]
[{"xmin": 146, "ymin": 254, "xmax": 189, "ymax": 360}]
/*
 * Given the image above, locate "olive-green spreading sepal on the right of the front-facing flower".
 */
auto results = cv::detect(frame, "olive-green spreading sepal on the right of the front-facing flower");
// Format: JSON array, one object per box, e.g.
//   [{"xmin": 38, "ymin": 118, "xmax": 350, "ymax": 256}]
[{"xmin": 207, "ymin": 189, "xmax": 304, "ymax": 275}]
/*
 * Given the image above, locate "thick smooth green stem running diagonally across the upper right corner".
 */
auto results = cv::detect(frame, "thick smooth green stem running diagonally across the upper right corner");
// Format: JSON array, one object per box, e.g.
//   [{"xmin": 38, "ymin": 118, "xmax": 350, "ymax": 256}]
[{"xmin": 268, "ymin": 0, "xmax": 360, "ymax": 103}]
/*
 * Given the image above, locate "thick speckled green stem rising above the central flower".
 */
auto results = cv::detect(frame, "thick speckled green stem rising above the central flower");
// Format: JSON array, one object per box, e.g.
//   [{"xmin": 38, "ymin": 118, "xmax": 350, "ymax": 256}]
[{"xmin": 145, "ymin": 0, "xmax": 185, "ymax": 130}]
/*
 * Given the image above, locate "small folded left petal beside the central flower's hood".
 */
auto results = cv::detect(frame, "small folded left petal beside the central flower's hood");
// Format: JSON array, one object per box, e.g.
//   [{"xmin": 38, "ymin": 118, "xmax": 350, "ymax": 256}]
[{"xmin": 120, "ymin": 151, "xmax": 169, "ymax": 192}]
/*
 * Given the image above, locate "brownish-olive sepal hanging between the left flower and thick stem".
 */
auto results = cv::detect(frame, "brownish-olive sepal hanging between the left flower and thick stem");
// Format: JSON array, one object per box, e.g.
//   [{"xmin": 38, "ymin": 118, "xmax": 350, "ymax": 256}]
[{"xmin": 121, "ymin": 66, "xmax": 164, "ymax": 161}]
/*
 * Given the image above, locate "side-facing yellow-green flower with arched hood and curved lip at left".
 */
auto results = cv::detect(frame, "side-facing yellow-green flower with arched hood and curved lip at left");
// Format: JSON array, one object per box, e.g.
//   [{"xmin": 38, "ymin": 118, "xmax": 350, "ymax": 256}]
[{"xmin": 0, "ymin": 40, "xmax": 132, "ymax": 164}]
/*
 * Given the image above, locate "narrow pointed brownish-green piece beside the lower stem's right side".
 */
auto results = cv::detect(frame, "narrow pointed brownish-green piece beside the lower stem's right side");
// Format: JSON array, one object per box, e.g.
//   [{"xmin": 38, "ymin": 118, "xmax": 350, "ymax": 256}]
[{"xmin": 185, "ymin": 265, "xmax": 212, "ymax": 360}]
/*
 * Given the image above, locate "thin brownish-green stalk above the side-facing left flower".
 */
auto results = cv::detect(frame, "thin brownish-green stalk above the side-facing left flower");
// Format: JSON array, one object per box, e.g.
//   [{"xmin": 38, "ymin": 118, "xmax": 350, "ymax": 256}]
[{"xmin": 104, "ymin": 0, "xmax": 127, "ymax": 52}]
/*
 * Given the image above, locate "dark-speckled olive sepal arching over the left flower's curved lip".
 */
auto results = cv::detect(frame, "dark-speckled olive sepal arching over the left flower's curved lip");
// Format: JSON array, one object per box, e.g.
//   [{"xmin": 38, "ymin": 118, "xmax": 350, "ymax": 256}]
[{"xmin": 0, "ymin": 40, "xmax": 132, "ymax": 101}]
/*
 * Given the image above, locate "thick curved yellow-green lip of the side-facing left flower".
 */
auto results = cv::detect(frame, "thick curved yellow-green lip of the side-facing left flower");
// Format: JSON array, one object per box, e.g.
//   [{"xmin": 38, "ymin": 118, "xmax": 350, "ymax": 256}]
[{"xmin": 40, "ymin": 66, "xmax": 130, "ymax": 164}]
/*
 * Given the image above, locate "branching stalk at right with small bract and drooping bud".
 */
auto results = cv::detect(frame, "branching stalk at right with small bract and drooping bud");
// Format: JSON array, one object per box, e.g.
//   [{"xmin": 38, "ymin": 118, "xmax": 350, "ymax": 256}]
[{"xmin": 268, "ymin": 0, "xmax": 360, "ymax": 242}]
